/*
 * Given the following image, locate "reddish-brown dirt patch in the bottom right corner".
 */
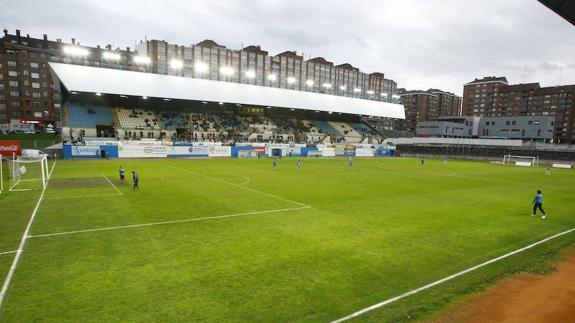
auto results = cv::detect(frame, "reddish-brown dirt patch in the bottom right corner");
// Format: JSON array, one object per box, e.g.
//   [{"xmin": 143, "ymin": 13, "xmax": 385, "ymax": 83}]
[{"xmin": 433, "ymin": 249, "xmax": 575, "ymax": 323}]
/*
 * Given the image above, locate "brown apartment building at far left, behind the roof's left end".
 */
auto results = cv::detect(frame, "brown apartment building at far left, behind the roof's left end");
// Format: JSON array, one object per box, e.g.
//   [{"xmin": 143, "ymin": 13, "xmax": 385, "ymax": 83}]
[{"xmin": 0, "ymin": 30, "xmax": 136, "ymax": 126}]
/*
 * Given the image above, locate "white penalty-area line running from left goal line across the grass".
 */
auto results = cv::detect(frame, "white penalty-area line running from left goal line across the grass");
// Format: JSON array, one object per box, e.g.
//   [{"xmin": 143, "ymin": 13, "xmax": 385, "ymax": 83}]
[{"xmin": 28, "ymin": 205, "xmax": 311, "ymax": 238}]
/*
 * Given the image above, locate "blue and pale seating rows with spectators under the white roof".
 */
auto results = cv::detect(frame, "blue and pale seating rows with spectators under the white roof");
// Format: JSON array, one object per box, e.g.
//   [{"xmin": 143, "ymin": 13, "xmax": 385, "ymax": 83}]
[{"xmin": 65, "ymin": 104, "xmax": 379, "ymax": 144}]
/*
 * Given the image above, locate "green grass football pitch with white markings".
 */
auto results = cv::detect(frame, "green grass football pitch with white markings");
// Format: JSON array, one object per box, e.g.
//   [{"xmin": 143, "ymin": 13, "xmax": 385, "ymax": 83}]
[{"xmin": 0, "ymin": 158, "xmax": 575, "ymax": 322}]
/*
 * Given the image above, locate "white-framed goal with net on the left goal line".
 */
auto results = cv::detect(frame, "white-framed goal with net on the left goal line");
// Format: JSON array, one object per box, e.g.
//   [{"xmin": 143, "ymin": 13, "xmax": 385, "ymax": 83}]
[{"xmin": 5, "ymin": 156, "xmax": 49, "ymax": 192}]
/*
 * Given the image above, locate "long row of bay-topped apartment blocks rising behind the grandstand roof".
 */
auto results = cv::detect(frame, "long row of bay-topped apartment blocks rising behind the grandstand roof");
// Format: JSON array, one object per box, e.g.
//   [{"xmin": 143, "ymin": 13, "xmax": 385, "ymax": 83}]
[{"xmin": 136, "ymin": 40, "xmax": 397, "ymax": 101}]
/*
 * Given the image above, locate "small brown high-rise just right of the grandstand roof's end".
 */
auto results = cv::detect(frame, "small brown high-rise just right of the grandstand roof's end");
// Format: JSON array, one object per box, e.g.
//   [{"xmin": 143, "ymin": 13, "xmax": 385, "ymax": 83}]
[{"xmin": 396, "ymin": 89, "xmax": 461, "ymax": 133}]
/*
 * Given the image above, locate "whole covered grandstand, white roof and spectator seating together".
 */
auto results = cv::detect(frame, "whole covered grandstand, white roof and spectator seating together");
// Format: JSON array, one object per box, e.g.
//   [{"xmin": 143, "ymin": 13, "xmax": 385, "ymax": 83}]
[{"xmin": 51, "ymin": 63, "xmax": 404, "ymax": 144}]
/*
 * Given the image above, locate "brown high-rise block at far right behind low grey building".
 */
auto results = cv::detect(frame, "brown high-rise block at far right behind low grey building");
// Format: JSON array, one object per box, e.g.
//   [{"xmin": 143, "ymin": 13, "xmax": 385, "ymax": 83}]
[{"xmin": 463, "ymin": 77, "xmax": 575, "ymax": 143}]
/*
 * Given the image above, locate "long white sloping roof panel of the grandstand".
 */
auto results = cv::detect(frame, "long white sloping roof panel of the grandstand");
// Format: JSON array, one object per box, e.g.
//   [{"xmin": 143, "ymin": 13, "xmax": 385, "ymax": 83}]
[{"xmin": 50, "ymin": 63, "xmax": 405, "ymax": 119}]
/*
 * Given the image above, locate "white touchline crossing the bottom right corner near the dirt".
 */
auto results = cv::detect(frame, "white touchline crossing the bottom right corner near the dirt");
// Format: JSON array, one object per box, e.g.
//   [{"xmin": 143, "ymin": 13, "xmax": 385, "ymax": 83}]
[{"xmin": 331, "ymin": 228, "xmax": 575, "ymax": 323}]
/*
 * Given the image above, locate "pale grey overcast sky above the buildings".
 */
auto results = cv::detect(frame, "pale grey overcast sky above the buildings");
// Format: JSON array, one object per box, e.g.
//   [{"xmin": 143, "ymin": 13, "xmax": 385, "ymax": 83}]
[{"xmin": 0, "ymin": 0, "xmax": 575, "ymax": 94}]
